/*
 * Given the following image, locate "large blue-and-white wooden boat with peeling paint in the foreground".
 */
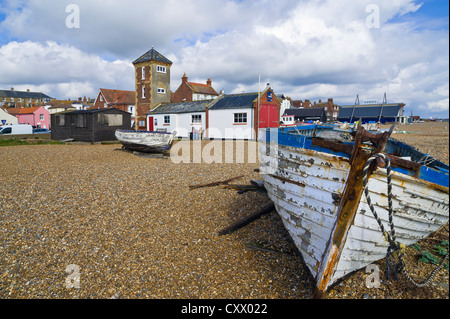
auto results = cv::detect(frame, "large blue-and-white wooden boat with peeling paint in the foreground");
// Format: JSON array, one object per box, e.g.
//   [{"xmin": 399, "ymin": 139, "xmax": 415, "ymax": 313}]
[{"xmin": 259, "ymin": 125, "xmax": 449, "ymax": 297}]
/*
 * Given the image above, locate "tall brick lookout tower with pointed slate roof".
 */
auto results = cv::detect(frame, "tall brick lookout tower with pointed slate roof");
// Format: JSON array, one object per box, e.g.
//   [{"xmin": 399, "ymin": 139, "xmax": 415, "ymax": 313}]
[{"xmin": 133, "ymin": 48, "xmax": 172, "ymax": 130}]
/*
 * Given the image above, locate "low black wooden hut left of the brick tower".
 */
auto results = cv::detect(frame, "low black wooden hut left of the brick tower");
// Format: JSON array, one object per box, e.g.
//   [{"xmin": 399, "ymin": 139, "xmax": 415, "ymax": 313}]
[{"xmin": 51, "ymin": 108, "xmax": 131, "ymax": 143}]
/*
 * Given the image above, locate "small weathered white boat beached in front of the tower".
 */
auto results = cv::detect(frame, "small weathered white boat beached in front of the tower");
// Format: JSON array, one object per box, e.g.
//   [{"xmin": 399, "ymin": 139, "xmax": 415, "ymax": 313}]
[{"xmin": 116, "ymin": 130, "xmax": 175, "ymax": 153}]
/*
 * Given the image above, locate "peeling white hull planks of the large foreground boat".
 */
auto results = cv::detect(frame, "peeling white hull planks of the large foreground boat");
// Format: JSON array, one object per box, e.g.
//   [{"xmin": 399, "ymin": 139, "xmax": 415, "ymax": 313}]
[{"xmin": 259, "ymin": 126, "xmax": 449, "ymax": 296}]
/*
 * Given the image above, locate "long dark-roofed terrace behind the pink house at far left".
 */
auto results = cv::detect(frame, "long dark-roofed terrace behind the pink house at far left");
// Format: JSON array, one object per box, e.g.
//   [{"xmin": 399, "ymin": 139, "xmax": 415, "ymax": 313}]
[{"xmin": 0, "ymin": 88, "xmax": 52, "ymax": 107}]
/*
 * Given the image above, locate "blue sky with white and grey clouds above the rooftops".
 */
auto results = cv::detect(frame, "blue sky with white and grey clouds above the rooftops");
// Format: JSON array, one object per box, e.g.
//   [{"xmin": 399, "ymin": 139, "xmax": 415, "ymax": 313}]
[{"xmin": 0, "ymin": 0, "xmax": 449, "ymax": 118}]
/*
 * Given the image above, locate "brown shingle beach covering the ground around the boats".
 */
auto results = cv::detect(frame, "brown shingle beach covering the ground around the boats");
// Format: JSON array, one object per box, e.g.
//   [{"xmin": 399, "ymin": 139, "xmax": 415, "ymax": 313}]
[{"xmin": 0, "ymin": 123, "xmax": 448, "ymax": 299}]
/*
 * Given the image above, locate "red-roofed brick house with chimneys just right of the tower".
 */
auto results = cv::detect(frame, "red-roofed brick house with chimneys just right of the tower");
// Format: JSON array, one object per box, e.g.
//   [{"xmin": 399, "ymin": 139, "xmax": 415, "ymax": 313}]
[{"xmin": 171, "ymin": 73, "xmax": 219, "ymax": 102}]
